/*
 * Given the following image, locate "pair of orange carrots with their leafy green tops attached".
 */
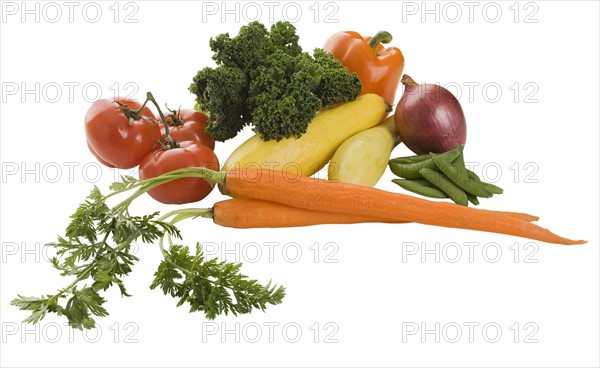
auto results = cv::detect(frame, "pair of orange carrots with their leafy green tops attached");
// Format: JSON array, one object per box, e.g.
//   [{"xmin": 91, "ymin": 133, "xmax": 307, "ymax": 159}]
[{"xmin": 12, "ymin": 167, "xmax": 586, "ymax": 329}]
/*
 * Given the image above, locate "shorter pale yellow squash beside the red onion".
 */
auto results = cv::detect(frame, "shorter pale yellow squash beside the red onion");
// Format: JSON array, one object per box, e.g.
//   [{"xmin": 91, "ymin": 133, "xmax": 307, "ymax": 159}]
[{"xmin": 328, "ymin": 115, "xmax": 400, "ymax": 187}]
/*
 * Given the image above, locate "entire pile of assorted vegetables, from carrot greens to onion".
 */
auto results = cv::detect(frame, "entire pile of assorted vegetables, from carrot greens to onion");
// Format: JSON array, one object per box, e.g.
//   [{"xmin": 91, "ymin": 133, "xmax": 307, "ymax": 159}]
[{"xmin": 11, "ymin": 22, "xmax": 585, "ymax": 329}]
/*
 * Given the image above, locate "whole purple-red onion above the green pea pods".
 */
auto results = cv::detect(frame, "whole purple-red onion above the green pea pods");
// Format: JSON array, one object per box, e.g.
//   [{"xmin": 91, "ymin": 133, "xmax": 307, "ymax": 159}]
[{"xmin": 394, "ymin": 74, "xmax": 467, "ymax": 154}]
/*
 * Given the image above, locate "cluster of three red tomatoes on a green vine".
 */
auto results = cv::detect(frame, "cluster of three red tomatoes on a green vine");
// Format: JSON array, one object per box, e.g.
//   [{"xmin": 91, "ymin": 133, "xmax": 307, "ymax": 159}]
[{"xmin": 85, "ymin": 93, "xmax": 219, "ymax": 204}]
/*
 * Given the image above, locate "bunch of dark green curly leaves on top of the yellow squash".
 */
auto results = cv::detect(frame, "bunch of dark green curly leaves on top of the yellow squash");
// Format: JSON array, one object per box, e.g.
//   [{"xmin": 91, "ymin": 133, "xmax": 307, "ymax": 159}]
[{"xmin": 190, "ymin": 22, "xmax": 361, "ymax": 141}]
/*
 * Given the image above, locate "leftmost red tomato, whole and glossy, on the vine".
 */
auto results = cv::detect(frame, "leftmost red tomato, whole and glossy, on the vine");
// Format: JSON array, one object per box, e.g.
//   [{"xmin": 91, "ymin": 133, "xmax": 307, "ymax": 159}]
[{"xmin": 85, "ymin": 98, "xmax": 160, "ymax": 169}]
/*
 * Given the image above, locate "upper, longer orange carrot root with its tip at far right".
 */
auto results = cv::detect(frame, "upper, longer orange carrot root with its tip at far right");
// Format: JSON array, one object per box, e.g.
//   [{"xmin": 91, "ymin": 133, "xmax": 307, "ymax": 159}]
[{"xmin": 224, "ymin": 168, "xmax": 586, "ymax": 245}]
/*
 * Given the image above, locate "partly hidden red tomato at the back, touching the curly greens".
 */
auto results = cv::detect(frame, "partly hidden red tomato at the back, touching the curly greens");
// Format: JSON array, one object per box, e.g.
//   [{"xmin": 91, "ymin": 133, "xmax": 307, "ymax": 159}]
[{"xmin": 160, "ymin": 109, "xmax": 215, "ymax": 150}]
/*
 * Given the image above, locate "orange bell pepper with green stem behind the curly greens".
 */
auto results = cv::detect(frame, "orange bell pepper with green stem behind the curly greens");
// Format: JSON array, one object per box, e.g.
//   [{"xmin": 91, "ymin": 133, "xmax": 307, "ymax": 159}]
[{"xmin": 323, "ymin": 31, "xmax": 404, "ymax": 104}]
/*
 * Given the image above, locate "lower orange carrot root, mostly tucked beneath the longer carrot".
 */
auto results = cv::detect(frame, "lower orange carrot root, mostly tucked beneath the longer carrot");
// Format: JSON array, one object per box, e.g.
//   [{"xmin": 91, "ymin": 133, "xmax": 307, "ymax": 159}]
[{"xmin": 212, "ymin": 198, "xmax": 404, "ymax": 229}]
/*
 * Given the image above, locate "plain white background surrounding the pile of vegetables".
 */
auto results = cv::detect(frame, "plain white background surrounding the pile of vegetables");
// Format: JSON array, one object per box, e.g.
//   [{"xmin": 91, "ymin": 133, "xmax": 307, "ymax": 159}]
[{"xmin": 0, "ymin": 1, "xmax": 600, "ymax": 367}]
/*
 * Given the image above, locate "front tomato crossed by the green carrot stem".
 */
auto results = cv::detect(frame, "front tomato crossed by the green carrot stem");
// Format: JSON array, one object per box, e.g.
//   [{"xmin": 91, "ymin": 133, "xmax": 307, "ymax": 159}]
[{"xmin": 139, "ymin": 141, "xmax": 219, "ymax": 204}]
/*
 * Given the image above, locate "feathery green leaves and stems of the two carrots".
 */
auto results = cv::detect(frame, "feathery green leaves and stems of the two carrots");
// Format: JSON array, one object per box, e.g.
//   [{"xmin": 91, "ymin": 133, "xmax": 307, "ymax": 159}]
[{"xmin": 11, "ymin": 171, "xmax": 285, "ymax": 329}]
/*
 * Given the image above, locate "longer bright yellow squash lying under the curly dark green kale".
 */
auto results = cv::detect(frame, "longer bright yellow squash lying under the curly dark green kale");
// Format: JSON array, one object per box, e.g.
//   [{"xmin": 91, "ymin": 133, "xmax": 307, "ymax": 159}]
[{"xmin": 223, "ymin": 94, "xmax": 387, "ymax": 176}]
